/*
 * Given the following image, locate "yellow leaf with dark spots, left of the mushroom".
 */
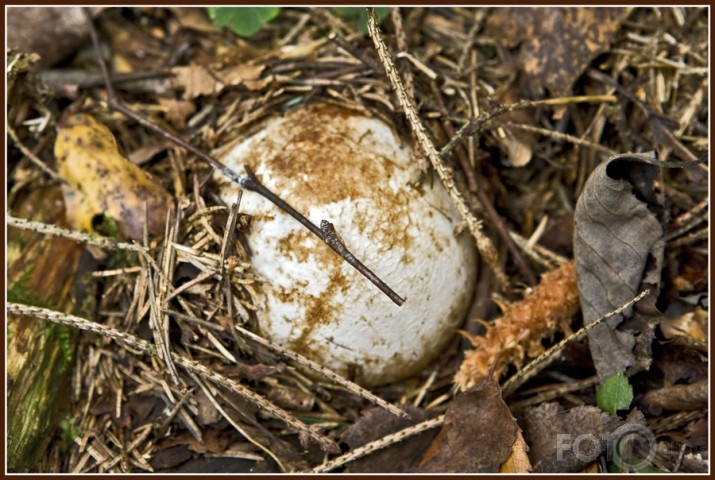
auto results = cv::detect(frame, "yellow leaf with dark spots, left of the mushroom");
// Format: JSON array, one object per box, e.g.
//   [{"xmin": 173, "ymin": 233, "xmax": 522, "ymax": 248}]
[{"xmin": 55, "ymin": 114, "xmax": 171, "ymax": 240}]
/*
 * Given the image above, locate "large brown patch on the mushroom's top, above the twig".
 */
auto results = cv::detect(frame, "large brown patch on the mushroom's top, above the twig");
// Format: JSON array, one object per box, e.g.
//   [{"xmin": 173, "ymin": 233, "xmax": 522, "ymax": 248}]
[{"xmin": 249, "ymin": 105, "xmax": 426, "ymax": 256}]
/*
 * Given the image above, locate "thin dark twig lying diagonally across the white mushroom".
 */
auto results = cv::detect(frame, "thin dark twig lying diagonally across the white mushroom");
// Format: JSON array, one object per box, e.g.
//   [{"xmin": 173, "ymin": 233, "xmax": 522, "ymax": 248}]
[{"xmin": 83, "ymin": 8, "xmax": 405, "ymax": 306}]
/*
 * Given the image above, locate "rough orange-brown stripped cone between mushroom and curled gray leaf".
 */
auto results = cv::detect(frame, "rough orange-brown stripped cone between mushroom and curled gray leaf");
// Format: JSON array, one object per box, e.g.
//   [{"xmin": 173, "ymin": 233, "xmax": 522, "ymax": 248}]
[{"xmin": 454, "ymin": 262, "xmax": 579, "ymax": 390}]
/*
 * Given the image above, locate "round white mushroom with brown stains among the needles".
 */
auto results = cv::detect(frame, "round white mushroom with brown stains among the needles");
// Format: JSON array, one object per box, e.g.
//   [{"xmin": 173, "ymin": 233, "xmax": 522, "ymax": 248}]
[{"xmin": 217, "ymin": 104, "xmax": 477, "ymax": 386}]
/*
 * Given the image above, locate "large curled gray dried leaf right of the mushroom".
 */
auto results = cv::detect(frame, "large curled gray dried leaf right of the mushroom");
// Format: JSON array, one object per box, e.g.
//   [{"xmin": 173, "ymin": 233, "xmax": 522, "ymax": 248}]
[{"xmin": 574, "ymin": 155, "xmax": 665, "ymax": 381}]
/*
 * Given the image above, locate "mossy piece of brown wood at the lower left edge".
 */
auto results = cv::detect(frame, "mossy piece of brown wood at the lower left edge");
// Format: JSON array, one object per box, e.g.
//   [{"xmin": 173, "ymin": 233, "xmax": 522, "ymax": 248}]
[{"xmin": 7, "ymin": 187, "xmax": 94, "ymax": 472}]
